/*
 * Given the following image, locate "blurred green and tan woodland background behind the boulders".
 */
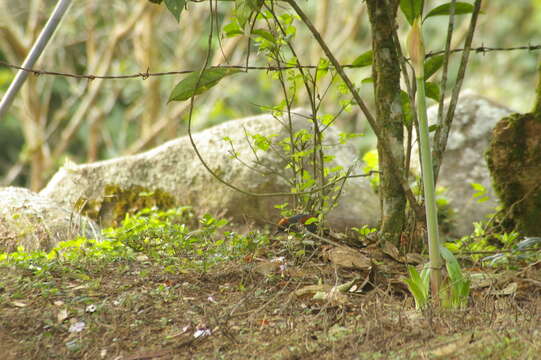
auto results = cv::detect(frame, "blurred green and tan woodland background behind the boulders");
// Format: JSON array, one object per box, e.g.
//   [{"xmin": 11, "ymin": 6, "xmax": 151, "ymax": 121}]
[{"xmin": 0, "ymin": 0, "xmax": 541, "ymax": 190}]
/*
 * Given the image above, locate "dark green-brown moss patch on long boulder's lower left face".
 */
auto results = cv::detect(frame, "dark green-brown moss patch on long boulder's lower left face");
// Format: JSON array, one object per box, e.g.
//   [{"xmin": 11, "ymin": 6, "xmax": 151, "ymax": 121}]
[{"xmin": 75, "ymin": 184, "xmax": 176, "ymax": 226}]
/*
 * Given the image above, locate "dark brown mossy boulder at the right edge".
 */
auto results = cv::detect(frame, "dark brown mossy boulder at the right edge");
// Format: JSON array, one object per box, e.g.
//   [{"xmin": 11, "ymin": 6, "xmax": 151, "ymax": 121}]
[{"xmin": 487, "ymin": 113, "xmax": 541, "ymax": 236}]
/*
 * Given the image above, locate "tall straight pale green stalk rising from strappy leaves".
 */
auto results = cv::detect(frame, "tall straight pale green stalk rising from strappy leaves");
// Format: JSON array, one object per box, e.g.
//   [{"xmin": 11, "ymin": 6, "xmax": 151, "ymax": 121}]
[{"xmin": 408, "ymin": 19, "xmax": 442, "ymax": 303}]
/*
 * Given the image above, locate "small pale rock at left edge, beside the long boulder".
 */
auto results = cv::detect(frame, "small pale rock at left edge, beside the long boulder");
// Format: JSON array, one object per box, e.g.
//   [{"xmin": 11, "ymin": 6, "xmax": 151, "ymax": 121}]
[{"xmin": 0, "ymin": 187, "xmax": 99, "ymax": 252}]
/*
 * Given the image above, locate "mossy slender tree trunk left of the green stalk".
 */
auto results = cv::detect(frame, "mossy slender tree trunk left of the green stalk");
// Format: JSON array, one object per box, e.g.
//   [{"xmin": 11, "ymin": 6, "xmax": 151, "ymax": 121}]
[{"xmin": 366, "ymin": 0, "xmax": 406, "ymax": 245}]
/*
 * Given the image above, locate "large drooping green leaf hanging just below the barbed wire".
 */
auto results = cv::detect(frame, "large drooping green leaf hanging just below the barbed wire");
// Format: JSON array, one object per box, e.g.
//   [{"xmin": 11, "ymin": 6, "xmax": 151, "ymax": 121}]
[{"xmin": 168, "ymin": 68, "xmax": 241, "ymax": 102}]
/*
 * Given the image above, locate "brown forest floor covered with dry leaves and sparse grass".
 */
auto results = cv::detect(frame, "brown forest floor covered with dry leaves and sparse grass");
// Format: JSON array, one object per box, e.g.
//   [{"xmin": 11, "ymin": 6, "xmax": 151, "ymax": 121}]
[{"xmin": 0, "ymin": 231, "xmax": 541, "ymax": 360}]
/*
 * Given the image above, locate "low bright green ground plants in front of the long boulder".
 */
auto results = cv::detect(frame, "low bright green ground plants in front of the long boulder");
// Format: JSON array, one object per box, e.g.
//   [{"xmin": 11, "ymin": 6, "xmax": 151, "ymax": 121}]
[{"xmin": 0, "ymin": 207, "xmax": 268, "ymax": 273}]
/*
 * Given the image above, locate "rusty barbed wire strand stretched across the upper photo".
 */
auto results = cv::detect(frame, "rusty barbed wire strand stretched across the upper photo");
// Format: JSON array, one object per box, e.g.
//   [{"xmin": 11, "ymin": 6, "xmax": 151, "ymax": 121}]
[{"xmin": 0, "ymin": 44, "xmax": 541, "ymax": 80}]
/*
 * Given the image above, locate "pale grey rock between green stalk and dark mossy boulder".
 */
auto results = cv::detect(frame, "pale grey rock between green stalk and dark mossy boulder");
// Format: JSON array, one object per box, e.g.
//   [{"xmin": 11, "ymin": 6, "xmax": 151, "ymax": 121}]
[{"xmin": 414, "ymin": 91, "xmax": 512, "ymax": 236}]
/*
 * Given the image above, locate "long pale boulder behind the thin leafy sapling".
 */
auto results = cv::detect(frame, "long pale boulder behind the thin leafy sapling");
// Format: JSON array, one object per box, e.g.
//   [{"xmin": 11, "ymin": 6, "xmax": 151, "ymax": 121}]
[{"xmin": 41, "ymin": 111, "xmax": 379, "ymax": 228}]
